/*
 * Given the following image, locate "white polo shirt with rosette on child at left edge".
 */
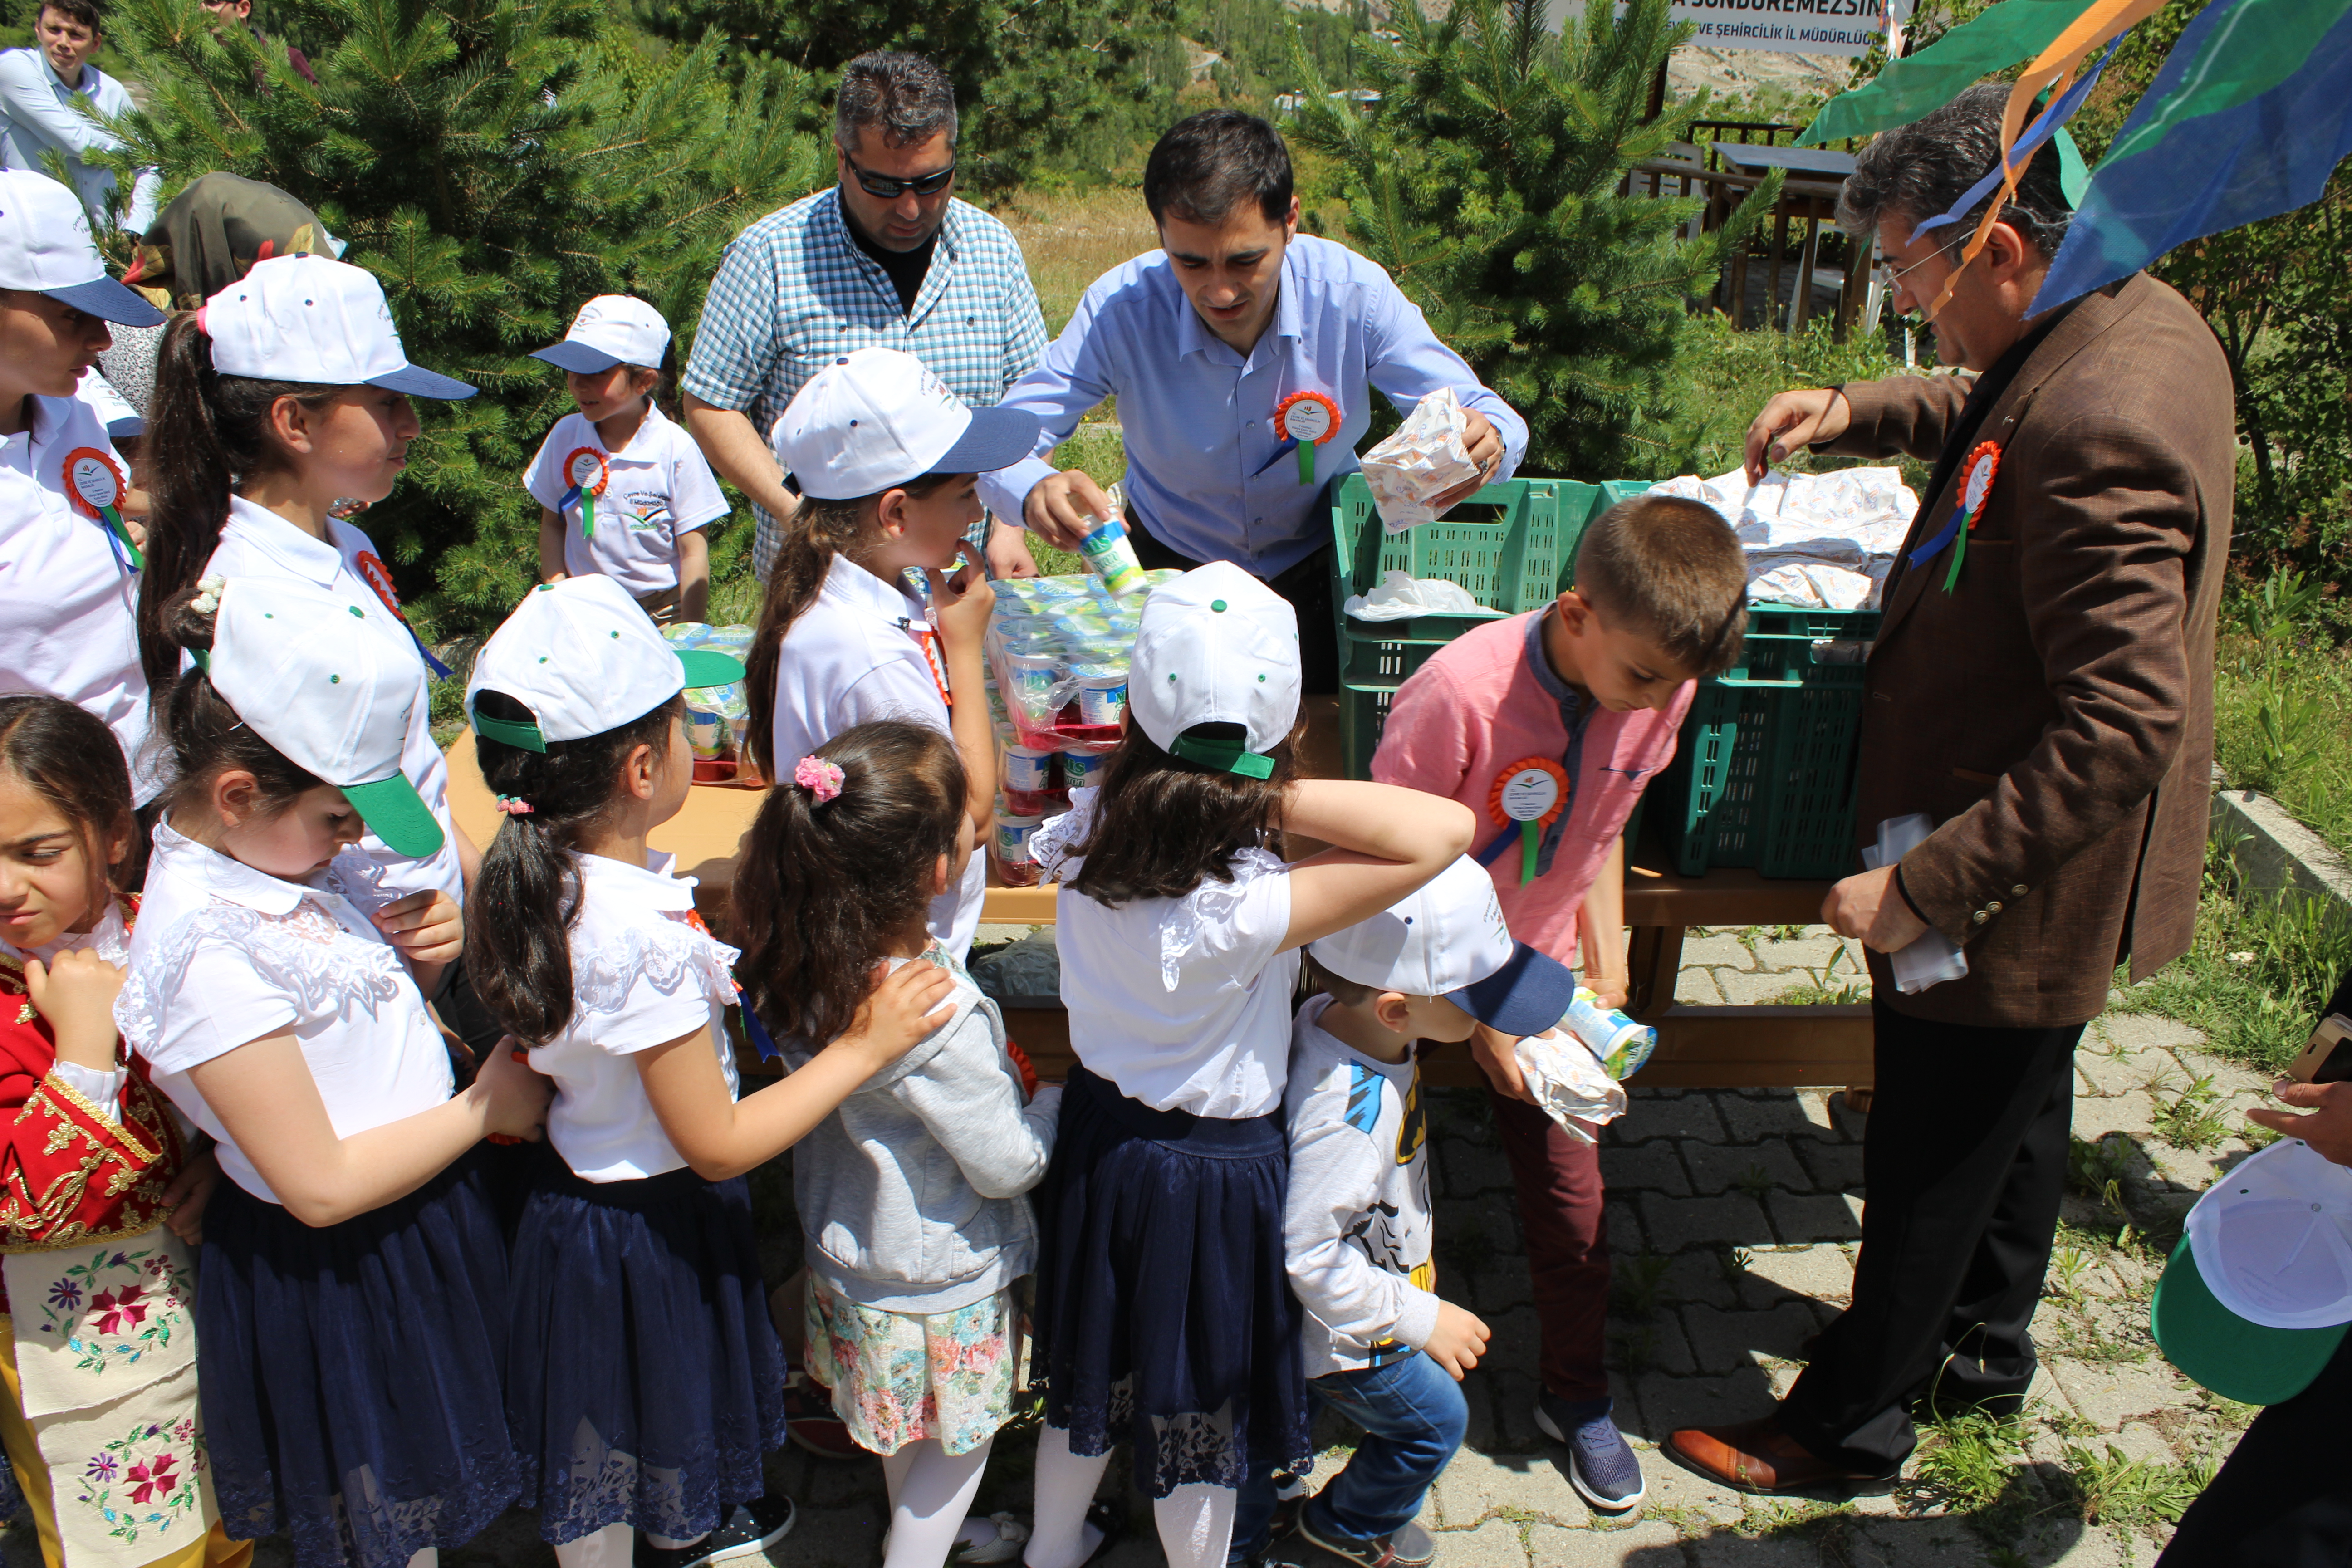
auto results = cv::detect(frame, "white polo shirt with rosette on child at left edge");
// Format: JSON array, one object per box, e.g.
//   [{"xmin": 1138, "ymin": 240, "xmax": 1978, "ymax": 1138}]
[{"xmin": 0, "ymin": 397, "xmax": 155, "ymax": 804}]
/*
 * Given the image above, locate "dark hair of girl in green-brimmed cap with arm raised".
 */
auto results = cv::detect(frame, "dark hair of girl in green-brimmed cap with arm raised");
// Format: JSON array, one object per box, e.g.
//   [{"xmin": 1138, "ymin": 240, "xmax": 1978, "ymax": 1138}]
[{"xmin": 1070, "ymin": 724, "xmax": 1296, "ymax": 910}]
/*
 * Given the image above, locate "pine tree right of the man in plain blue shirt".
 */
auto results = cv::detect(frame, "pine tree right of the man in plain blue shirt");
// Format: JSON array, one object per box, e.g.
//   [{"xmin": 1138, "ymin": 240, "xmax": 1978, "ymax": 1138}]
[{"xmin": 1294, "ymin": 0, "xmax": 1780, "ymax": 480}]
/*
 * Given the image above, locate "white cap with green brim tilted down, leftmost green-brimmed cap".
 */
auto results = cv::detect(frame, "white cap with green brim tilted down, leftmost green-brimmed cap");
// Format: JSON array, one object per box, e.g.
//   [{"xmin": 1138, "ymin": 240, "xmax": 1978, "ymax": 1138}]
[{"xmin": 202, "ymin": 578, "xmax": 442, "ymax": 858}]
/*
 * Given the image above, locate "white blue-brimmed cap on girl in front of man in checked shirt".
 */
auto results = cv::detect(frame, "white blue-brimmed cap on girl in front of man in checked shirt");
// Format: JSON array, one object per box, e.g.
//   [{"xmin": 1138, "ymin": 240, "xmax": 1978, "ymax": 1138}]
[{"xmin": 769, "ymin": 348, "xmax": 1042, "ymax": 501}]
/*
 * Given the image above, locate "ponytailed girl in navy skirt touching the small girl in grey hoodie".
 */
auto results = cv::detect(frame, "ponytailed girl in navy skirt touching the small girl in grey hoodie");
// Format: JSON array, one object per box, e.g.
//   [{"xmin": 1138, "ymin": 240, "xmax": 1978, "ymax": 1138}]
[{"xmin": 466, "ymin": 576, "xmax": 953, "ymax": 1568}]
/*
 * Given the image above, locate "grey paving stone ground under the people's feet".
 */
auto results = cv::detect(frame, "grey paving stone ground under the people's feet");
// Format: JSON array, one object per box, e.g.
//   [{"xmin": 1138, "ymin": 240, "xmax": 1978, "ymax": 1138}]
[{"xmin": 7, "ymin": 926, "xmax": 2265, "ymax": 1568}]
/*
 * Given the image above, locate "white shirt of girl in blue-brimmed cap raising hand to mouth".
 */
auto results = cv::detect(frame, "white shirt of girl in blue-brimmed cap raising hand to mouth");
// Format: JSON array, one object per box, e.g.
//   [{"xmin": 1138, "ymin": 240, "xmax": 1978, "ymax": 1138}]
[{"xmin": 771, "ymin": 555, "xmax": 988, "ymax": 964}]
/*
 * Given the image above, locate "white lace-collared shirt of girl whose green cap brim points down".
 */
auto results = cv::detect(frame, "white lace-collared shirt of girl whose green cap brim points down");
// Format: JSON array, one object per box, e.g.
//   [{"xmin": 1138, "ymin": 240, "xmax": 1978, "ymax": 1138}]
[{"xmin": 115, "ymin": 823, "xmax": 454, "ymax": 1204}]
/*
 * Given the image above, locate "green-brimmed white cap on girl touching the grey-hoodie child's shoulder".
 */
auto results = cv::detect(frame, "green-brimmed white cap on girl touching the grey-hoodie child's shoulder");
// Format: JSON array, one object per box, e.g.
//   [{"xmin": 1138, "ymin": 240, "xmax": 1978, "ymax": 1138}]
[{"xmin": 466, "ymin": 576, "xmax": 743, "ymax": 752}]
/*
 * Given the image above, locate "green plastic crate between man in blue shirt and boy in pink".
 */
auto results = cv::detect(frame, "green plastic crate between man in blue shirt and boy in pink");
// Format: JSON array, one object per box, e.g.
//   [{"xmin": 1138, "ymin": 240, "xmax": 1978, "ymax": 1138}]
[{"xmin": 1331, "ymin": 475, "xmax": 1649, "ymax": 778}]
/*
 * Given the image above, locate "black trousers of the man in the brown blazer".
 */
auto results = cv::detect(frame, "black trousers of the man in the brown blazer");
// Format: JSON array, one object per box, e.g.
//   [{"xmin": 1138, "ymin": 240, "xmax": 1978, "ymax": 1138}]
[{"xmin": 1780, "ymin": 1001, "xmax": 2082, "ymax": 1474}]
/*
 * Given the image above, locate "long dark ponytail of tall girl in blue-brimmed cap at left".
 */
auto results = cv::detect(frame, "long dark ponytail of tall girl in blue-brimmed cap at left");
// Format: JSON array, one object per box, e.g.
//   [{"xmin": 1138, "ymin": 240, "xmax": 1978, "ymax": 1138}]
[{"xmin": 139, "ymin": 315, "xmax": 348, "ymax": 691}]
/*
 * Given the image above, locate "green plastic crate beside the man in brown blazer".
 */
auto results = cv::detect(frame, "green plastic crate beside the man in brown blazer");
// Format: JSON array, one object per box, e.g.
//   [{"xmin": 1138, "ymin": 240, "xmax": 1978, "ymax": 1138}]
[{"xmin": 1649, "ymin": 604, "xmax": 1879, "ymax": 877}]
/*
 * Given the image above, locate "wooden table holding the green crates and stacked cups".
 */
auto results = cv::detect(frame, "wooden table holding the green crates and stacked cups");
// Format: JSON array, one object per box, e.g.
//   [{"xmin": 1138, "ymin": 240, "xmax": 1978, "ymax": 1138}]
[{"xmin": 449, "ymin": 698, "xmax": 1872, "ymax": 1088}]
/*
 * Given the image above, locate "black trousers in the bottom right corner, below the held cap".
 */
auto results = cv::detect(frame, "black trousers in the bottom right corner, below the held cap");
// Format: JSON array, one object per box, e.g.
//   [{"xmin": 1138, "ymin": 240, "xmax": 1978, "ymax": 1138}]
[{"xmin": 2157, "ymin": 1338, "xmax": 2352, "ymax": 1568}]
